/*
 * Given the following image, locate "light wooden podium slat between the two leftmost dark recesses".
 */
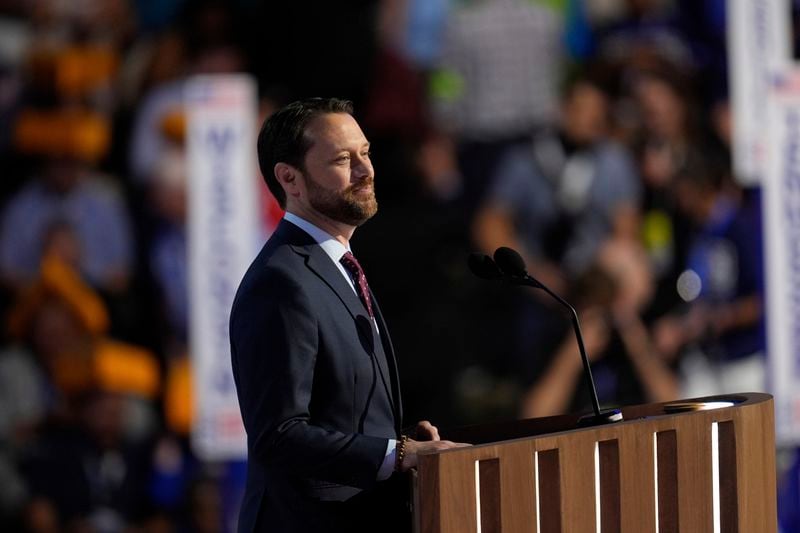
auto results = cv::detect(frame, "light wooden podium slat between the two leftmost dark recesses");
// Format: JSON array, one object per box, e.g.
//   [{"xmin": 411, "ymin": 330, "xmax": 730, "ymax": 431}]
[{"xmin": 500, "ymin": 442, "xmax": 536, "ymax": 533}]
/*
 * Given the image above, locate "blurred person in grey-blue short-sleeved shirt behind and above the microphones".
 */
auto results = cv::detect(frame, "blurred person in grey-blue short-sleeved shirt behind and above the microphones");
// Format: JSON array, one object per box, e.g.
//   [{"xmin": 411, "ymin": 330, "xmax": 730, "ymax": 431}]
[{"xmin": 473, "ymin": 79, "xmax": 640, "ymax": 375}]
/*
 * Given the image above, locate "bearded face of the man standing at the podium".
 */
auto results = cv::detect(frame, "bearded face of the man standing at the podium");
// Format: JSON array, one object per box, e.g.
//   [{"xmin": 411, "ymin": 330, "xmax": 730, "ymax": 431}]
[{"xmin": 303, "ymin": 113, "xmax": 378, "ymax": 226}]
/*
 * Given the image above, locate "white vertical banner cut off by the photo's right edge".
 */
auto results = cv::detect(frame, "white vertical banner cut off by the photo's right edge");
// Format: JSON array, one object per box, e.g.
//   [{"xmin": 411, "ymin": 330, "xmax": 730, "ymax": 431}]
[{"xmin": 763, "ymin": 67, "xmax": 800, "ymax": 445}]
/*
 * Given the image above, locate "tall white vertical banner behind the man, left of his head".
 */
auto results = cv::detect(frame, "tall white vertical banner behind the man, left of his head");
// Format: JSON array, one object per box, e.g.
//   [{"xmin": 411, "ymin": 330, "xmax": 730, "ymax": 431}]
[{"xmin": 186, "ymin": 75, "xmax": 261, "ymax": 460}]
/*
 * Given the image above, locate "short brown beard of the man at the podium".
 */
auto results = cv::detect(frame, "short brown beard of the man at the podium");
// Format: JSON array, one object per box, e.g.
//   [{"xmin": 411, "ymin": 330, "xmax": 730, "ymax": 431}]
[{"xmin": 306, "ymin": 175, "xmax": 378, "ymax": 226}]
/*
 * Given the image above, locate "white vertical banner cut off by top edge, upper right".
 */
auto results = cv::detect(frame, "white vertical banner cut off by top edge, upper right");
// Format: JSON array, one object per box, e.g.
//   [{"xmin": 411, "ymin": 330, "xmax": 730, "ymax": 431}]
[{"xmin": 727, "ymin": 0, "xmax": 791, "ymax": 185}]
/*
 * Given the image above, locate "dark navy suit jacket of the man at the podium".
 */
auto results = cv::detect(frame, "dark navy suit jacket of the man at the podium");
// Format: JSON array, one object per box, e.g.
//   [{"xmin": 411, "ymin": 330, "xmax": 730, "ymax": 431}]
[{"xmin": 230, "ymin": 220, "xmax": 401, "ymax": 533}]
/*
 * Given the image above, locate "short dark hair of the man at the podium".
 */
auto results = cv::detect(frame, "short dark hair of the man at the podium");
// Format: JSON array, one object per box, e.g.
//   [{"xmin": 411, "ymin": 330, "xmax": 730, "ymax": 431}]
[{"xmin": 258, "ymin": 98, "xmax": 353, "ymax": 209}]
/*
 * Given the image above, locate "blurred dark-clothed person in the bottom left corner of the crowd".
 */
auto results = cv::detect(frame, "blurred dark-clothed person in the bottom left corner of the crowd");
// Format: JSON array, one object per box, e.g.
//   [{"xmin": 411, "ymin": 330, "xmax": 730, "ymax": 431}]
[{"xmin": 24, "ymin": 387, "xmax": 156, "ymax": 533}]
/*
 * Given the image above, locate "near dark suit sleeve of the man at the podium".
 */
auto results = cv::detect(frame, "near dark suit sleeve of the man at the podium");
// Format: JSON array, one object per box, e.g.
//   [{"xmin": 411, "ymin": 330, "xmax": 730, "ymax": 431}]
[{"xmin": 231, "ymin": 267, "xmax": 388, "ymax": 488}]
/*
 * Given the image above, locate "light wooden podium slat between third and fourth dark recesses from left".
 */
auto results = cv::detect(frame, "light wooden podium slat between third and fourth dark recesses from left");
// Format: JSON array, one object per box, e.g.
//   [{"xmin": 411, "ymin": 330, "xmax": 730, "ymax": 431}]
[{"xmin": 620, "ymin": 427, "xmax": 656, "ymax": 533}]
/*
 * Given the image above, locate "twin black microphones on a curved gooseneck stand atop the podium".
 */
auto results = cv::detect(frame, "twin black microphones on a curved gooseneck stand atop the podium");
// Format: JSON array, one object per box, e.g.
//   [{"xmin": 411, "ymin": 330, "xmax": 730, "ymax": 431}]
[{"xmin": 468, "ymin": 246, "xmax": 622, "ymax": 426}]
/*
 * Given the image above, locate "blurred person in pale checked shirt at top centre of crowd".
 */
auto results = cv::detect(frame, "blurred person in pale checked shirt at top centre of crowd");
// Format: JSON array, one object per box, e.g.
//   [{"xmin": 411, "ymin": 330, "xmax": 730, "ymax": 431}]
[{"xmin": 430, "ymin": 0, "xmax": 563, "ymax": 211}]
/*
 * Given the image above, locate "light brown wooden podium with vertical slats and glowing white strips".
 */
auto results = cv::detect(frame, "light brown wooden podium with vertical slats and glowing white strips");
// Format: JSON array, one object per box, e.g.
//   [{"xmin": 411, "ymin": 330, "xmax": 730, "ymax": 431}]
[{"xmin": 414, "ymin": 393, "xmax": 777, "ymax": 533}]
